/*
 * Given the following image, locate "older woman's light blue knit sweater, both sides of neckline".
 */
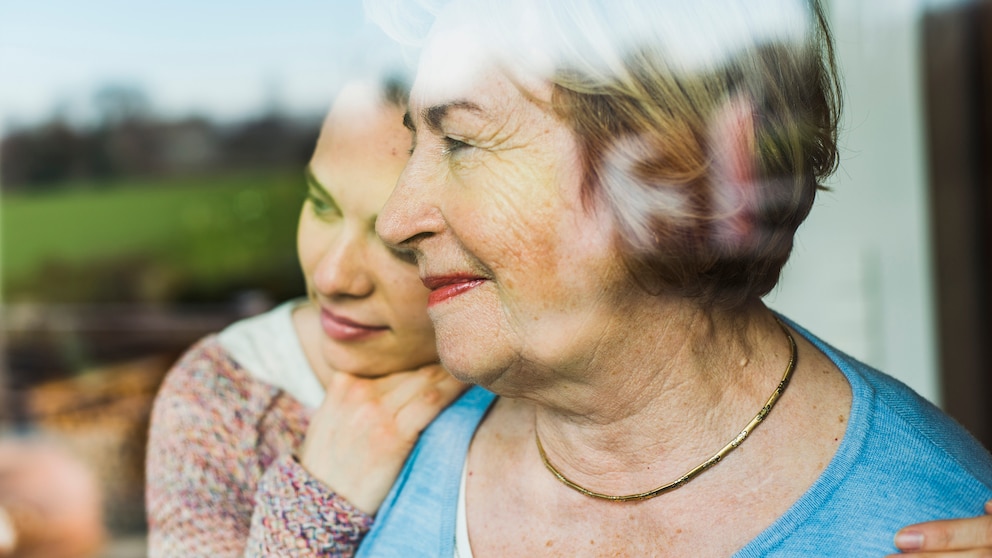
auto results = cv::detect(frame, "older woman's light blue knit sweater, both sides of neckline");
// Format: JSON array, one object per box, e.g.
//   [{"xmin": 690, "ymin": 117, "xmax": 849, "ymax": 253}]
[{"xmin": 358, "ymin": 322, "xmax": 992, "ymax": 558}]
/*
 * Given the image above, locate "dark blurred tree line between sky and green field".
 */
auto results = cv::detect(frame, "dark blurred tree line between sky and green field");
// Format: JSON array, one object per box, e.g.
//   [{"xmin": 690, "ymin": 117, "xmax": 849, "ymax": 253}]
[{"xmin": 0, "ymin": 85, "xmax": 320, "ymax": 192}]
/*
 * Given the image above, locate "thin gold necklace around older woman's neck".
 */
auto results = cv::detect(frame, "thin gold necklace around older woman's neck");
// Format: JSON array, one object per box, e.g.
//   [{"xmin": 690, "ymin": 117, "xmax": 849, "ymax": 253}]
[{"xmin": 534, "ymin": 318, "xmax": 797, "ymax": 502}]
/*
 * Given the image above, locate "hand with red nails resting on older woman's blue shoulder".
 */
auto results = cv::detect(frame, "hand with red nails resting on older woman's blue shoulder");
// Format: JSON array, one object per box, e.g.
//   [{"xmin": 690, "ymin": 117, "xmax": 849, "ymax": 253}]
[{"xmin": 896, "ymin": 500, "xmax": 992, "ymax": 558}]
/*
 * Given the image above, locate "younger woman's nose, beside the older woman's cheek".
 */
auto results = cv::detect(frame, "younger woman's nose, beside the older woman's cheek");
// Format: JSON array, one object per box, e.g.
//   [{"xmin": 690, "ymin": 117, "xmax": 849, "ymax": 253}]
[{"xmin": 313, "ymin": 231, "xmax": 375, "ymax": 298}]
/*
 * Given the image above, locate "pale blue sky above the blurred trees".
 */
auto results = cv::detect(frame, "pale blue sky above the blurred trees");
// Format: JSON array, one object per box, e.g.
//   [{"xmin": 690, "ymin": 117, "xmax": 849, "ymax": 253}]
[{"xmin": 0, "ymin": 0, "xmax": 403, "ymax": 126}]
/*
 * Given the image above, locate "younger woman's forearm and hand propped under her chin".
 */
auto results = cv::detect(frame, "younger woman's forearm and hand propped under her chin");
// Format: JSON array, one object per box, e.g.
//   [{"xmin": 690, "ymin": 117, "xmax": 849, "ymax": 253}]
[{"xmin": 247, "ymin": 365, "xmax": 467, "ymax": 557}]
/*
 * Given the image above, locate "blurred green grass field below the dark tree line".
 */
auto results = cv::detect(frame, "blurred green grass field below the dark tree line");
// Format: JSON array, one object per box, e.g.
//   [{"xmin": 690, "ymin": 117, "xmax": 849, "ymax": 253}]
[{"xmin": 0, "ymin": 168, "xmax": 304, "ymax": 302}]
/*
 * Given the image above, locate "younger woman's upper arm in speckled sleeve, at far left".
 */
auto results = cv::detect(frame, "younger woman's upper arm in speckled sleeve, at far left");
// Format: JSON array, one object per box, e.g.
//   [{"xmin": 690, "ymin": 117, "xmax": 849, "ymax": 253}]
[{"xmin": 146, "ymin": 342, "xmax": 268, "ymax": 557}]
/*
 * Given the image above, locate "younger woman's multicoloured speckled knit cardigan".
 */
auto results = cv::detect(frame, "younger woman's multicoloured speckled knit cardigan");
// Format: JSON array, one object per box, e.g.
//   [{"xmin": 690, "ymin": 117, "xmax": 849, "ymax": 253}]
[{"xmin": 146, "ymin": 335, "xmax": 372, "ymax": 558}]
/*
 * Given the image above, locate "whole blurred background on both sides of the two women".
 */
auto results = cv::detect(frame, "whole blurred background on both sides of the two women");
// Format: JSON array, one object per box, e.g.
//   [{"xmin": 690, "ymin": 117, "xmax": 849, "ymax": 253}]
[{"xmin": 0, "ymin": 0, "xmax": 992, "ymax": 557}]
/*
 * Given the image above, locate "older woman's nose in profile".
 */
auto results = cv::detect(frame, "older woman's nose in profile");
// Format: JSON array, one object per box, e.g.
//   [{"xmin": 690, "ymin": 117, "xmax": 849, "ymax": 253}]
[{"xmin": 375, "ymin": 152, "xmax": 444, "ymax": 251}]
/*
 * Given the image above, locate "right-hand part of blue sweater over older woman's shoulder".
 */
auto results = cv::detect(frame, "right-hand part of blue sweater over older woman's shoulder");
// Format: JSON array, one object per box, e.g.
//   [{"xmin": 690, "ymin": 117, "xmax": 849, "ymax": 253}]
[{"xmin": 738, "ymin": 320, "xmax": 992, "ymax": 556}]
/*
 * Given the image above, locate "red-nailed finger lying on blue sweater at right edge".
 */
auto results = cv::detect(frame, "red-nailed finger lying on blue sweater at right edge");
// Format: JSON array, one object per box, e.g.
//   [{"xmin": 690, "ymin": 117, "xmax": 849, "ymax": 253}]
[{"xmin": 895, "ymin": 515, "xmax": 992, "ymax": 552}]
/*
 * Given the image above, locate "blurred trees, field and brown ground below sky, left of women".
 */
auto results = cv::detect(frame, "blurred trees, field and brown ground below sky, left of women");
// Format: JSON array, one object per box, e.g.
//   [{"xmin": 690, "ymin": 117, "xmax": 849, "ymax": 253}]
[{"xmin": 0, "ymin": 85, "xmax": 320, "ymax": 533}]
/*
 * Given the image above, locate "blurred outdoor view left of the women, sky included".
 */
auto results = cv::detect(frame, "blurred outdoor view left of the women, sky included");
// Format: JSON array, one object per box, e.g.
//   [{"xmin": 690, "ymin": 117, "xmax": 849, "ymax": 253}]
[{"xmin": 0, "ymin": 0, "xmax": 407, "ymax": 556}]
